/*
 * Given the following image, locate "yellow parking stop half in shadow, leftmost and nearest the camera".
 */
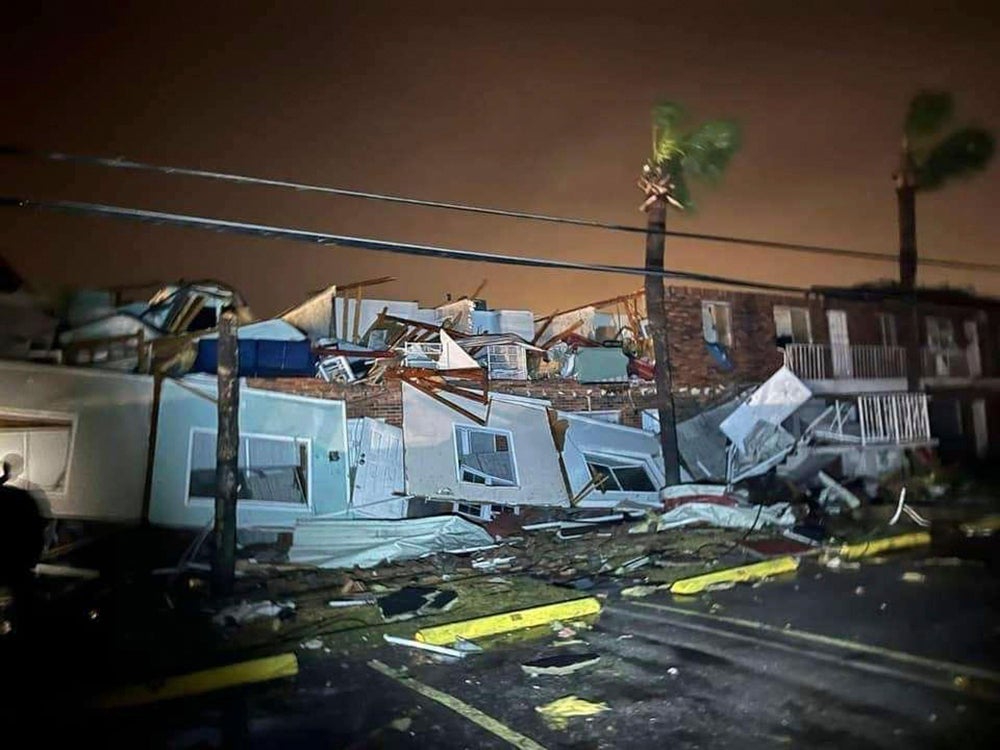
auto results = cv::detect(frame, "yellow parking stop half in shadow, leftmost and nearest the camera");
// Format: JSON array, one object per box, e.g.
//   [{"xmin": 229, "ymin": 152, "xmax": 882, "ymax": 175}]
[{"xmin": 96, "ymin": 654, "xmax": 299, "ymax": 708}]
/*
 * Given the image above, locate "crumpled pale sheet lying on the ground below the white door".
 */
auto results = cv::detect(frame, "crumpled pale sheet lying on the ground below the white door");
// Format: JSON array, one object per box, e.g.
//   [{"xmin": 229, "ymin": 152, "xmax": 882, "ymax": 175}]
[{"xmin": 288, "ymin": 516, "xmax": 493, "ymax": 568}]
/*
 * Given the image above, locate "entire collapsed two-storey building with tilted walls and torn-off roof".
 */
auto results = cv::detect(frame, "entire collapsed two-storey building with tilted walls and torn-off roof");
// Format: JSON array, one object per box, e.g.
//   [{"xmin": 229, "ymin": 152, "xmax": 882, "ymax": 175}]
[{"xmin": 0, "ymin": 256, "xmax": 1000, "ymax": 529}]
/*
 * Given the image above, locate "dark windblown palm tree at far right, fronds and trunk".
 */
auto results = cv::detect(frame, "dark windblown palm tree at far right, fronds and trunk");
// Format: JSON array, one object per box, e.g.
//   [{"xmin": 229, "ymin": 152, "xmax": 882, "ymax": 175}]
[{"xmin": 893, "ymin": 91, "xmax": 995, "ymax": 391}]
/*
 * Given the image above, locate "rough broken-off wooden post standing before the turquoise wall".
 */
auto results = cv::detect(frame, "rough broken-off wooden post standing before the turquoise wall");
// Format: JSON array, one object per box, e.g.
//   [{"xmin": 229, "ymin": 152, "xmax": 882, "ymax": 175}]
[{"xmin": 212, "ymin": 310, "xmax": 240, "ymax": 596}]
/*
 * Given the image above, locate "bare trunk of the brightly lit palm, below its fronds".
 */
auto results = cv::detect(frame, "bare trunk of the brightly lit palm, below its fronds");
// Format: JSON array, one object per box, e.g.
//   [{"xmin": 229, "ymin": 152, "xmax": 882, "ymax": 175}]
[{"xmin": 646, "ymin": 198, "xmax": 681, "ymax": 486}]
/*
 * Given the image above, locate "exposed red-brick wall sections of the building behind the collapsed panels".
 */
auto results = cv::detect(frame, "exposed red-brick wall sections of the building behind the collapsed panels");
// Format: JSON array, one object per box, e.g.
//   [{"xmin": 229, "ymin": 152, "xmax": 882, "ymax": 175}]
[{"xmin": 251, "ymin": 286, "xmax": 1000, "ymax": 468}]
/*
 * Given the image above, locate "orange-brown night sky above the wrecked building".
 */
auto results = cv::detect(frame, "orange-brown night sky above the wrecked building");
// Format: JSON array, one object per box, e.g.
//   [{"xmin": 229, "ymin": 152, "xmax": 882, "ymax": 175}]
[{"xmin": 0, "ymin": 0, "xmax": 1000, "ymax": 314}]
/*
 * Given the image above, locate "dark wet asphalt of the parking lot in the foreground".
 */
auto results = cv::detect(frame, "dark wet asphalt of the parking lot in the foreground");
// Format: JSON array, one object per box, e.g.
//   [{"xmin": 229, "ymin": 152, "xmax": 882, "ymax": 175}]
[{"xmin": 19, "ymin": 554, "xmax": 1000, "ymax": 748}]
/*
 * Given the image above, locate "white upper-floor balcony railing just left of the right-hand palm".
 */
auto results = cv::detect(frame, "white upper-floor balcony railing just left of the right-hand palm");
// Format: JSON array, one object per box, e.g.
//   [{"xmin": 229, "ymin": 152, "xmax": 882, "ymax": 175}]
[{"xmin": 785, "ymin": 344, "xmax": 906, "ymax": 380}]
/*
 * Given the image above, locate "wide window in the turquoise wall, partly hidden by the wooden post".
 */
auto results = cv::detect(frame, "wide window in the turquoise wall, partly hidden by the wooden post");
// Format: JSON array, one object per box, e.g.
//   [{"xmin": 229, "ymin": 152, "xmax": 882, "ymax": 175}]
[{"xmin": 188, "ymin": 429, "xmax": 309, "ymax": 505}]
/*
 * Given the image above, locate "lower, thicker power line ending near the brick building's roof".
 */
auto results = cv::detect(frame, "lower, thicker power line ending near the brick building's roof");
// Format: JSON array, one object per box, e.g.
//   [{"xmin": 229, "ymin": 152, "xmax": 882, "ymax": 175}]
[{"xmin": 0, "ymin": 197, "xmax": 808, "ymax": 293}]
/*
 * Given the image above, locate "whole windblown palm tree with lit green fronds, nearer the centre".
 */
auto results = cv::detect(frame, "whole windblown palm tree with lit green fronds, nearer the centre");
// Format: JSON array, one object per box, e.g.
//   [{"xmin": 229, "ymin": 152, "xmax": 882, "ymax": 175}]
[{"xmin": 639, "ymin": 102, "xmax": 740, "ymax": 485}]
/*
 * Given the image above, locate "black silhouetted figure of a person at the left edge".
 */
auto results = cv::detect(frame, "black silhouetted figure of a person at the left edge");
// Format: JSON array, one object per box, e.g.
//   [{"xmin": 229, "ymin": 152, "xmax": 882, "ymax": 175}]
[{"xmin": 0, "ymin": 455, "xmax": 48, "ymax": 636}]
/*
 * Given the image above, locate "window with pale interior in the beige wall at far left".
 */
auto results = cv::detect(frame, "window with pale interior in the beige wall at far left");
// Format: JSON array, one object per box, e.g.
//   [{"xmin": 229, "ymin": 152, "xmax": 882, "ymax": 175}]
[{"xmin": 0, "ymin": 413, "xmax": 73, "ymax": 492}]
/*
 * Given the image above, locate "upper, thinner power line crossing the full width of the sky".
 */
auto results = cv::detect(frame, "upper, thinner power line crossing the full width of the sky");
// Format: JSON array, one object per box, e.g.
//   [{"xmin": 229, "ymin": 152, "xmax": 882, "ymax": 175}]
[{"xmin": 0, "ymin": 146, "xmax": 1000, "ymax": 273}]
